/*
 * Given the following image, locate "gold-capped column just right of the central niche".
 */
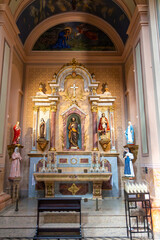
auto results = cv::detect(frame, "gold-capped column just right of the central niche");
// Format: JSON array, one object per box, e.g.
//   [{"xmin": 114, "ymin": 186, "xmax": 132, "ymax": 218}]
[{"xmin": 91, "ymin": 105, "xmax": 98, "ymax": 151}]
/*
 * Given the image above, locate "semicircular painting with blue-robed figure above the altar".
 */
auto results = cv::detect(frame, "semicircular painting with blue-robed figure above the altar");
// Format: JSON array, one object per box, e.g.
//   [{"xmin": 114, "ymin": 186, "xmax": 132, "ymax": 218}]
[{"xmin": 33, "ymin": 22, "xmax": 116, "ymax": 51}]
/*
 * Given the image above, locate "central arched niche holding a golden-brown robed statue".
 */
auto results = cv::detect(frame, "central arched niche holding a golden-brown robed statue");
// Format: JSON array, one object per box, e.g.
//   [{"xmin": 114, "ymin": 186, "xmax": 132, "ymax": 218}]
[{"xmin": 67, "ymin": 113, "xmax": 82, "ymax": 150}]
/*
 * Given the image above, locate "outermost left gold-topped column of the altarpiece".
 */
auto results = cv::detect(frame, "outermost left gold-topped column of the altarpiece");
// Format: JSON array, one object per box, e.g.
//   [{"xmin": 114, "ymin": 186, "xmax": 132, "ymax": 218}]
[{"xmin": 32, "ymin": 106, "xmax": 39, "ymax": 151}]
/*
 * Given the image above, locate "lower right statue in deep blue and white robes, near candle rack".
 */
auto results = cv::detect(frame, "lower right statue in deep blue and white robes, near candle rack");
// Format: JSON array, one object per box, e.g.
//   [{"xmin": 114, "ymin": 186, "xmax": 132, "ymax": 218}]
[{"xmin": 123, "ymin": 148, "xmax": 135, "ymax": 177}]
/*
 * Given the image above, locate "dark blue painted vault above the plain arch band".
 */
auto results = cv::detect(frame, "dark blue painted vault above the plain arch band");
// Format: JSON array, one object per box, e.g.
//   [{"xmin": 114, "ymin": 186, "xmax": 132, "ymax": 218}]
[{"xmin": 17, "ymin": 0, "xmax": 129, "ymax": 44}]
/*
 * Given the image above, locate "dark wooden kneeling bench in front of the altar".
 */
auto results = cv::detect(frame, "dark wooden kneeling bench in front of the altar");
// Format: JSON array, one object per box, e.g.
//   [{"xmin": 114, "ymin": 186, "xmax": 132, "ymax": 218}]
[{"xmin": 34, "ymin": 198, "xmax": 82, "ymax": 240}]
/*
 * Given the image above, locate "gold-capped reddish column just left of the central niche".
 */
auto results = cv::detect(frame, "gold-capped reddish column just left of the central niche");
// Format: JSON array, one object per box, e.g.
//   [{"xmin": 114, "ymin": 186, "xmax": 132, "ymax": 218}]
[{"xmin": 50, "ymin": 105, "xmax": 57, "ymax": 151}]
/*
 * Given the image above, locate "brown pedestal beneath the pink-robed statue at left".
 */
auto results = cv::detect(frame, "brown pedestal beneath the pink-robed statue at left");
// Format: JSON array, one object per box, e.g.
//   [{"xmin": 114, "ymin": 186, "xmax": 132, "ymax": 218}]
[{"xmin": 8, "ymin": 177, "xmax": 21, "ymax": 202}]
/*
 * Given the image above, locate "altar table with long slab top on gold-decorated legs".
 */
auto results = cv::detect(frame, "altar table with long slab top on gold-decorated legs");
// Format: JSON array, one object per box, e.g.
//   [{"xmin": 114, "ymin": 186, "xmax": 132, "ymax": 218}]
[{"xmin": 34, "ymin": 172, "xmax": 112, "ymax": 199}]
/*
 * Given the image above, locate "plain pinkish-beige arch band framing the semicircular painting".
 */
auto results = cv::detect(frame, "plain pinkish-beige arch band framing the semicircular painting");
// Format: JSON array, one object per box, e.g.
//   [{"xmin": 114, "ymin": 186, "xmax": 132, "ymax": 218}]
[{"xmin": 24, "ymin": 12, "xmax": 124, "ymax": 55}]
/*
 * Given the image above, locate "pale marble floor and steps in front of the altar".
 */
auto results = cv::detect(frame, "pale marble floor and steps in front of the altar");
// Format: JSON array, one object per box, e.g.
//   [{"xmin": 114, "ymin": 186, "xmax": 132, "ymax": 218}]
[{"xmin": 0, "ymin": 199, "xmax": 154, "ymax": 240}]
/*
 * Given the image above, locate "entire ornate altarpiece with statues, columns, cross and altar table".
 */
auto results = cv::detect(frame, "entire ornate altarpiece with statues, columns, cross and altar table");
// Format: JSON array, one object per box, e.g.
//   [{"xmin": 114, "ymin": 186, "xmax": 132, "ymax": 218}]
[{"xmin": 28, "ymin": 59, "xmax": 119, "ymax": 198}]
